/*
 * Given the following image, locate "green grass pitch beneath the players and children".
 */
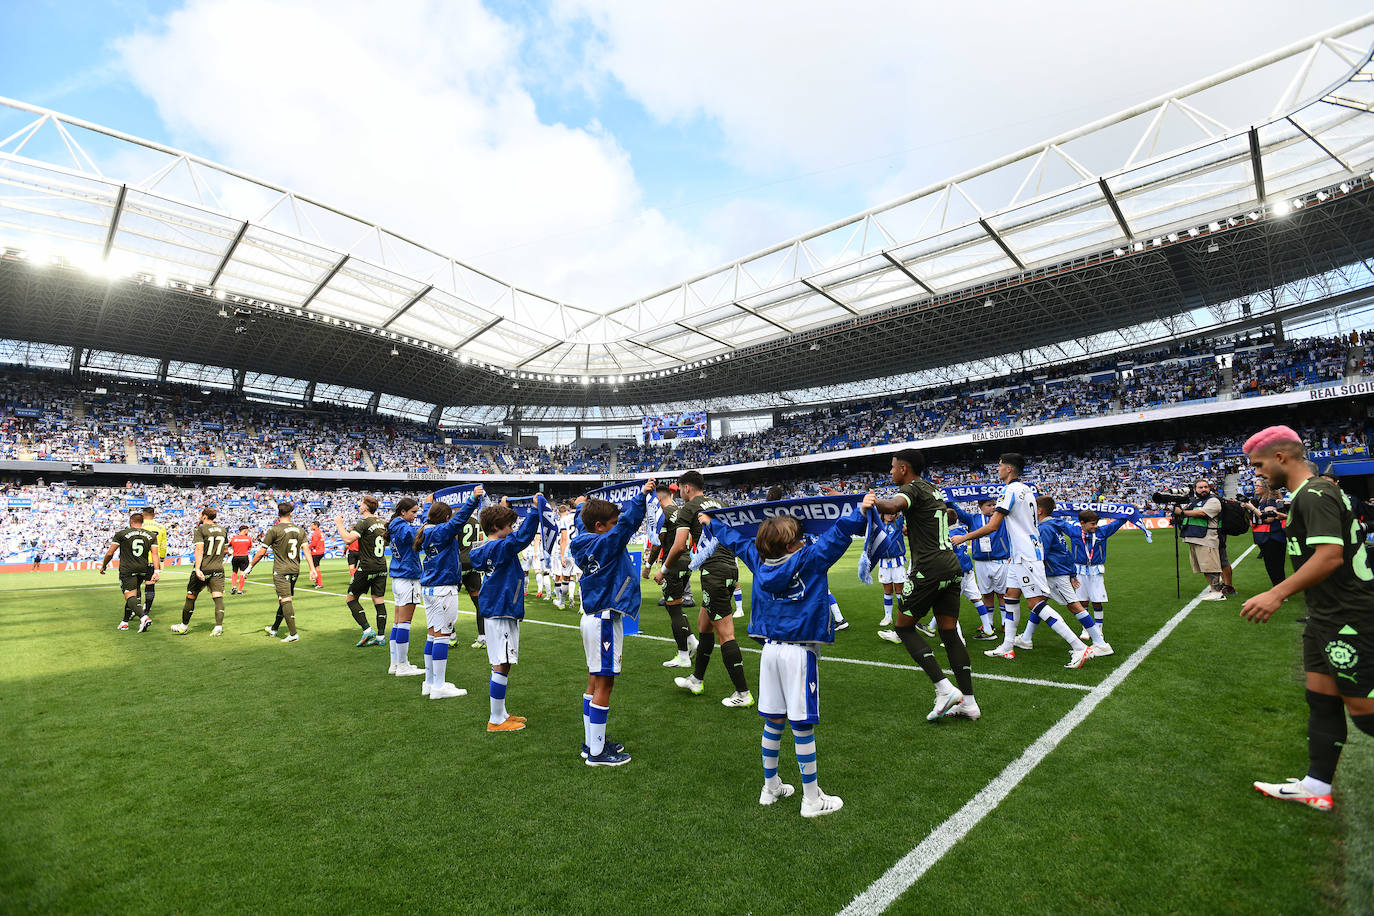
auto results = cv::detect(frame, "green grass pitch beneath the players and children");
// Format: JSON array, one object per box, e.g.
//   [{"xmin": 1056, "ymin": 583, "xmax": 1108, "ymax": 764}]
[{"xmin": 0, "ymin": 533, "xmax": 1374, "ymax": 913}]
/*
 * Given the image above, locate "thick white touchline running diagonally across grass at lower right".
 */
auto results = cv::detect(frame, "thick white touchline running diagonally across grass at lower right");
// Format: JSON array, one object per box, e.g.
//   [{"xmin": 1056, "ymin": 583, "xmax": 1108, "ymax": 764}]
[{"xmin": 840, "ymin": 544, "xmax": 1254, "ymax": 916}]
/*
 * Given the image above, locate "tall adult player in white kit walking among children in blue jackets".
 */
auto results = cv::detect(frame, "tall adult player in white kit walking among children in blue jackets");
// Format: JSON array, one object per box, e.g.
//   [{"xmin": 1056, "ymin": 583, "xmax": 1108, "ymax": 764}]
[{"xmin": 951, "ymin": 452, "xmax": 1050, "ymax": 659}]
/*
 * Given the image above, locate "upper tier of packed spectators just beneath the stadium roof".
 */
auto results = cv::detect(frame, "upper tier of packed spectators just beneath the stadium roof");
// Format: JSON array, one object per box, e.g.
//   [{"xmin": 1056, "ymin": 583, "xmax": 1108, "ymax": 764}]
[{"xmin": 0, "ymin": 331, "xmax": 1374, "ymax": 475}]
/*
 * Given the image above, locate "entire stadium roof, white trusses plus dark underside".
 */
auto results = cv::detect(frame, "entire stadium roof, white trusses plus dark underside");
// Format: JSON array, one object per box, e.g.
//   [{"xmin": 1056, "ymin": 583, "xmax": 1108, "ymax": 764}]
[{"xmin": 0, "ymin": 15, "xmax": 1374, "ymax": 405}]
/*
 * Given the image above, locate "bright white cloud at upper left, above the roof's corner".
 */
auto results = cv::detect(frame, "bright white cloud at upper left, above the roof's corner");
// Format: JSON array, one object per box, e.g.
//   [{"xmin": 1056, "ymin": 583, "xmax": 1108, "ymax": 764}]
[{"xmin": 117, "ymin": 0, "xmax": 721, "ymax": 306}]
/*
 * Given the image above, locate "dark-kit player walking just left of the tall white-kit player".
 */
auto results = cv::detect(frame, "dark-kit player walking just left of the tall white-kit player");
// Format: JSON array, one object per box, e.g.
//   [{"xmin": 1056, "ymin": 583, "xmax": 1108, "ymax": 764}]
[{"xmin": 877, "ymin": 449, "xmax": 982, "ymax": 722}]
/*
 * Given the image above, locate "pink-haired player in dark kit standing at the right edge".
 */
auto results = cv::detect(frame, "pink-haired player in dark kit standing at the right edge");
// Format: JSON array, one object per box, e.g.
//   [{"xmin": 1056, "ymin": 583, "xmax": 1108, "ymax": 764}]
[{"xmin": 1241, "ymin": 426, "xmax": 1374, "ymax": 812}]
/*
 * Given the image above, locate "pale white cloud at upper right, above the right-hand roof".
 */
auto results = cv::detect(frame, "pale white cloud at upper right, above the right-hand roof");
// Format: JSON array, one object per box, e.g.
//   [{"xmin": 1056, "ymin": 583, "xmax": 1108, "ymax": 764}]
[{"xmin": 555, "ymin": 0, "xmax": 1367, "ymax": 210}]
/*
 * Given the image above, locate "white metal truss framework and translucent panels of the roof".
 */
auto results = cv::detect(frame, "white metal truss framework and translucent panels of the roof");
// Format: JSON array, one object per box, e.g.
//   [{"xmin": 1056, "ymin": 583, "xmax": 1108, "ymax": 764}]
[{"xmin": 0, "ymin": 14, "xmax": 1374, "ymax": 385}]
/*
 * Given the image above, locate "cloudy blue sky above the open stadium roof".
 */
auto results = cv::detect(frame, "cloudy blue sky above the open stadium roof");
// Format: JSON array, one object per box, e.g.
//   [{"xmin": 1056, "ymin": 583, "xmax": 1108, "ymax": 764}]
[{"xmin": 0, "ymin": 0, "xmax": 1369, "ymax": 309}]
